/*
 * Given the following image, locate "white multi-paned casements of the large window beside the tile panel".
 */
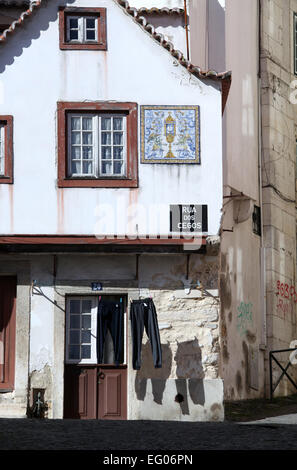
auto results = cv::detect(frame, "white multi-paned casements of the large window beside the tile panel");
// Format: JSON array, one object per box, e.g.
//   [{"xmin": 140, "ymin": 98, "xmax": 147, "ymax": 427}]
[{"xmin": 68, "ymin": 114, "xmax": 127, "ymax": 178}]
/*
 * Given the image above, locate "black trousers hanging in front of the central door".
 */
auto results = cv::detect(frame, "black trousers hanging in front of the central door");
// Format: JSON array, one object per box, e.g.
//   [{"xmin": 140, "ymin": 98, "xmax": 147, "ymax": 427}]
[{"xmin": 97, "ymin": 300, "xmax": 124, "ymax": 365}]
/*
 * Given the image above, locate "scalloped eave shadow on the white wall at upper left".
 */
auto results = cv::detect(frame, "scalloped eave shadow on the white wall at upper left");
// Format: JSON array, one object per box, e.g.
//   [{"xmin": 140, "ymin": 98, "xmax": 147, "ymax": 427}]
[{"xmin": 0, "ymin": 0, "xmax": 75, "ymax": 73}]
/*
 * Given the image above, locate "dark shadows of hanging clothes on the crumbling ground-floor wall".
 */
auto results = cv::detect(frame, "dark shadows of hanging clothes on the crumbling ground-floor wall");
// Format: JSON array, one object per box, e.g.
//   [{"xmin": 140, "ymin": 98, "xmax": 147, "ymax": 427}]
[{"xmin": 135, "ymin": 338, "xmax": 205, "ymax": 415}]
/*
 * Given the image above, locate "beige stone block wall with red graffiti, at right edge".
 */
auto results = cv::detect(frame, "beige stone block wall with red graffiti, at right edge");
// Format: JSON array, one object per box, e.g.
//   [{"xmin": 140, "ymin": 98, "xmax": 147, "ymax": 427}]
[{"xmin": 261, "ymin": 0, "xmax": 297, "ymax": 395}]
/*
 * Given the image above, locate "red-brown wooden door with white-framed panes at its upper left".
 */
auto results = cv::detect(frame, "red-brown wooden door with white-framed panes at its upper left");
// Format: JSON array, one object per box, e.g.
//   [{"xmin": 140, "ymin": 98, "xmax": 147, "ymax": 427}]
[{"xmin": 64, "ymin": 297, "xmax": 127, "ymax": 419}]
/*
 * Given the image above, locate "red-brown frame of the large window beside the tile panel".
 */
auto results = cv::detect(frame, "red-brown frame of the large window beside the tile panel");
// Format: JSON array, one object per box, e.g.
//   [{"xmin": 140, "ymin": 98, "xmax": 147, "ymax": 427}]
[{"xmin": 57, "ymin": 101, "xmax": 138, "ymax": 188}]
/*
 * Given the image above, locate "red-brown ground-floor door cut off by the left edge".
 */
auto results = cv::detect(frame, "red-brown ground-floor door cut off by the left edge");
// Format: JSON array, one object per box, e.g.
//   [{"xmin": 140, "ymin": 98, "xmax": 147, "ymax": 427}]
[{"xmin": 0, "ymin": 276, "xmax": 17, "ymax": 392}]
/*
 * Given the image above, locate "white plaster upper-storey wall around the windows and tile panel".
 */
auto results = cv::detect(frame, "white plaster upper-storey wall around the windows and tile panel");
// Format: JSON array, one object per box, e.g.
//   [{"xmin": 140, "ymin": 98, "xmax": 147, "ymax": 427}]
[{"xmin": 0, "ymin": 0, "xmax": 222, "ymax": 234}]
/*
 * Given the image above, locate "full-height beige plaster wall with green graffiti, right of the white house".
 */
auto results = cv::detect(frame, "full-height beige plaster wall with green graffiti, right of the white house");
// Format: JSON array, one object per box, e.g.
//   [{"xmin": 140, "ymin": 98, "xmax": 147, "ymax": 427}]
[{"xmin": 217, "ymin": 0, "xmax": 266, "ymax": 400}]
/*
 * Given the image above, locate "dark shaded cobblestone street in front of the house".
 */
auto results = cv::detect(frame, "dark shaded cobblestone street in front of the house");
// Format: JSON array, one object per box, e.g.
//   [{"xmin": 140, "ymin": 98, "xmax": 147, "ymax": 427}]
[{"xmin": 0, "ymin": 419, "xmax": 297, "ymax": 451}]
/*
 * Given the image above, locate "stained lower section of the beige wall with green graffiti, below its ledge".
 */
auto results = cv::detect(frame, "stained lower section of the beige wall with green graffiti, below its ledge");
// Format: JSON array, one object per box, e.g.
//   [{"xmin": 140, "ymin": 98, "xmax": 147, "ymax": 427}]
[{"xmin": 220, "ymin": 204, "xmax": 265, "ymax": 400}]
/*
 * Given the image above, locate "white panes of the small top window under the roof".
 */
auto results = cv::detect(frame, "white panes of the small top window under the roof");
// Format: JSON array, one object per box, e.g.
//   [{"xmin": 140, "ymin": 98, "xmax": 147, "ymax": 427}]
[{"xmin": 67, "ymin": 16, "xmax": 98, "ymax": 43}]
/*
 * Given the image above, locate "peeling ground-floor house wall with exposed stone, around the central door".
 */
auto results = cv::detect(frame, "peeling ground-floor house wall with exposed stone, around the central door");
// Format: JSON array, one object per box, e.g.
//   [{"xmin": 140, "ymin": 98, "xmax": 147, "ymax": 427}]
[{"xmin": 0, "ymin": 253, "xmax": 224, "ymax": 421}]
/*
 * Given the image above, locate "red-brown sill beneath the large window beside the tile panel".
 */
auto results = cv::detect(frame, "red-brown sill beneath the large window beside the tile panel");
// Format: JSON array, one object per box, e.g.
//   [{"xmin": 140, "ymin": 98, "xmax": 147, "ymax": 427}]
[{"xmin": 58, "ymin": 178, "xmax": 138, "ymax": 188}]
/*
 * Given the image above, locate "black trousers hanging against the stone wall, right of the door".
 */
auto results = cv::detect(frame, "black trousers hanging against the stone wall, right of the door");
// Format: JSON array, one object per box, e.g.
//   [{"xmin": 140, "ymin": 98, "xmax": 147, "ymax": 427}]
[{"xmin": 130, "ymin": 299, "xmax": 162, "ymax": 370}]
